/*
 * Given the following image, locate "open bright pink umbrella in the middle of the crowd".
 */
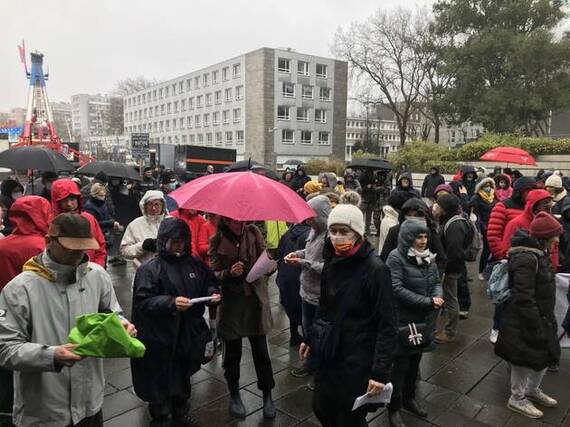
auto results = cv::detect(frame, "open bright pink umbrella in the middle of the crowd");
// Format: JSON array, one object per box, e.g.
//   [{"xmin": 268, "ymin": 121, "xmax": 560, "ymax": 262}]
[{"xmin": 169, "ymin": 172, "xmax": 315, "ymax": 223}]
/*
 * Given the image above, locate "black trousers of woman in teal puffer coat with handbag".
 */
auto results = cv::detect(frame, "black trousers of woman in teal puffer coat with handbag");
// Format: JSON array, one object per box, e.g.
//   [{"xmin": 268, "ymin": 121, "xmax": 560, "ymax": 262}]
[{"xmin": 388, "ymin": 352, "xmax": 423, "ymax": 411}]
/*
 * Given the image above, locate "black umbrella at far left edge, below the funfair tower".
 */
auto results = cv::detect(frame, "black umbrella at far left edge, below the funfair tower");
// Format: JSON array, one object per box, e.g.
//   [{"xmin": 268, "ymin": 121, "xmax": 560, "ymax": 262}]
[{"xmin": 0, "ymin": 146, "xmax": 75, "ymax": 173}]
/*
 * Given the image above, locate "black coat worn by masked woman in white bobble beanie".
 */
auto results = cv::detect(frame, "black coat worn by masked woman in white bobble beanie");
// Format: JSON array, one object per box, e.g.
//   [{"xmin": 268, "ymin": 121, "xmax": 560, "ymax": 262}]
[{"xmin": 316, "ymin": 241, "xmax": 397, "ymax": 411}]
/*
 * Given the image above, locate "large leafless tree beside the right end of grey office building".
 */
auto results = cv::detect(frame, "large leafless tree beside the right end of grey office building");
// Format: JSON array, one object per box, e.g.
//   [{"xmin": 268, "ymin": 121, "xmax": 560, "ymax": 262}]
[{"xmin": 334, "ymin": 8, "xmax": 427, "ymax": 145}]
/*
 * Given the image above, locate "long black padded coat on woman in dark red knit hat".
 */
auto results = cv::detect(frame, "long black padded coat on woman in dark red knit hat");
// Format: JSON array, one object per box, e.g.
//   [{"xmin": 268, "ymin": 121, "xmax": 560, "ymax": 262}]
[{"xmin": 495, "ymin": 230, "xmax": 560, "ymax": 371}]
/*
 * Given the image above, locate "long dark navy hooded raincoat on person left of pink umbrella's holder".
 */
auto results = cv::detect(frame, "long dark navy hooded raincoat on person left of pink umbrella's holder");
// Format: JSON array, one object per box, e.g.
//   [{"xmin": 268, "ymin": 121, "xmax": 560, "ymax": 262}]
[{"xmin": 131, "ymin": 218, "xmax": 219, "ymax": 402}]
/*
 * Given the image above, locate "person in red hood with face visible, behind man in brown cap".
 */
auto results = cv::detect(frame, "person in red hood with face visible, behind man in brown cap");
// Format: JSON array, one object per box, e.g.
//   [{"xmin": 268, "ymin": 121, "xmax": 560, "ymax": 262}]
[{"xmin": 51, "ymin": 179, "xmax": 107, "ymax": 268}]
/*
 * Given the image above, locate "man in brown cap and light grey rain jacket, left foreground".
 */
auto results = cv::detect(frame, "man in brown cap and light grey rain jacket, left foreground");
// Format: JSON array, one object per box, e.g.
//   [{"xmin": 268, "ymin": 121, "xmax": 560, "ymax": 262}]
[{"xmin": 0, "ymin": 213, "xmax": 136, "ymax": 427}]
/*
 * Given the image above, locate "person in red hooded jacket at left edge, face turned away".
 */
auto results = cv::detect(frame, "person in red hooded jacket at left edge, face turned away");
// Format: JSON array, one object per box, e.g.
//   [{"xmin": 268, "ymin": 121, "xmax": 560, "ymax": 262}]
[{"xmin": 0, "ymin": 196, "xmax": 50, "ymax": 290}]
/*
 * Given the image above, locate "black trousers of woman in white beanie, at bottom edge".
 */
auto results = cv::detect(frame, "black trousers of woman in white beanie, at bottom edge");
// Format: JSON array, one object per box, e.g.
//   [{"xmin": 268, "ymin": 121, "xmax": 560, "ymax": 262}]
[{"xmin": 313, "ymin": 381, "xmax": 368, "ymax": 427}]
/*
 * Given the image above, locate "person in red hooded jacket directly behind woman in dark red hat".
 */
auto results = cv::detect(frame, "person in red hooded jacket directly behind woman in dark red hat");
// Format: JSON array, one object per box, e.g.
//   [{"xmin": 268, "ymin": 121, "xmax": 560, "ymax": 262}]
[{"xmin": 500, "ymin": 190, "xmax": 558, "ymax": 271}]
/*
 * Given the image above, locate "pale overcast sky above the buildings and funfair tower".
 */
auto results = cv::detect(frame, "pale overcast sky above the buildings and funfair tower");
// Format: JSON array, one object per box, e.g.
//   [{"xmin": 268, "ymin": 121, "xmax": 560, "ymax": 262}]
[{"xmin": 0, "ymin": 0, "xmax": 432, "ymax": 112}]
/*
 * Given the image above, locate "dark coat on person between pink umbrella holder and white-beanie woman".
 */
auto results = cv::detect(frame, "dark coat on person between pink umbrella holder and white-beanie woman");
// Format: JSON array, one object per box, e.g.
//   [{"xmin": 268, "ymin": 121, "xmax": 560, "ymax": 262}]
[{"xmin": 276, "ymin": 224, "xmax": 311, "ymax": 325}]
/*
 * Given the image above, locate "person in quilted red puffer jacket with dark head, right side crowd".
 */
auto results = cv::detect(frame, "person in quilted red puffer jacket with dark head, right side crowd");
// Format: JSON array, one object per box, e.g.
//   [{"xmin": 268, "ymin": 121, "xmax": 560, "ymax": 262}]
[{"xmin": 487, "ymin": 176, "xmax": 536, "ymax": 260}]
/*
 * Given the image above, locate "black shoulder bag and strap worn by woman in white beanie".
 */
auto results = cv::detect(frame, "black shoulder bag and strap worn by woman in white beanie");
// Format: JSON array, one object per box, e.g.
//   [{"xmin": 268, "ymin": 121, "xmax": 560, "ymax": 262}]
[{"xmin": 310, "ymin": 257, "xmax": 368, "ymax": 370}]
